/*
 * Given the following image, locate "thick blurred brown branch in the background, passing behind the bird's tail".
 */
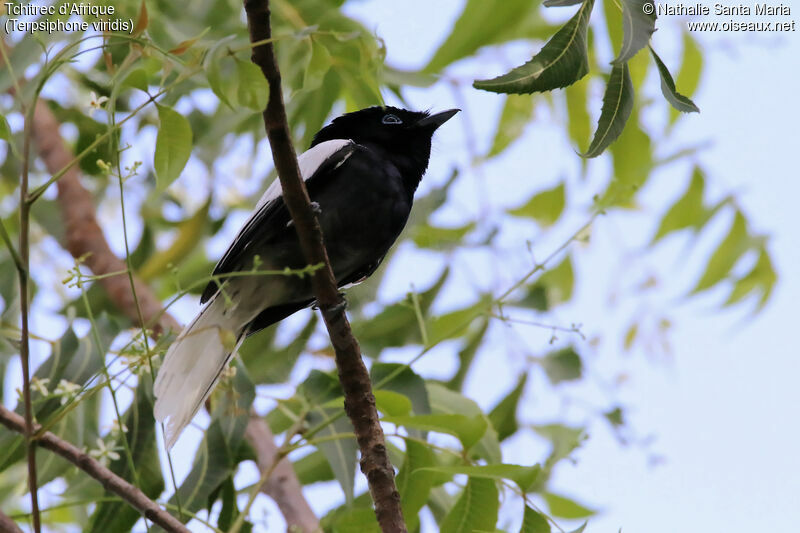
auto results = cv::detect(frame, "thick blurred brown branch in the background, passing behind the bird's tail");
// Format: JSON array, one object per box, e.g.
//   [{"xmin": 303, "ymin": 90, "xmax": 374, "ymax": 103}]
[{"xmin": 25, "ymin": 95, "xmax": 320, "ymax": 533}]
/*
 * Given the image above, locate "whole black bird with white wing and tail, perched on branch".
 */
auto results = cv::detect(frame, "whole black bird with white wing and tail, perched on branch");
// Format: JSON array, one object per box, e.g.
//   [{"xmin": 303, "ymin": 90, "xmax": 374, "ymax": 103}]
[{"xmin": 154, "ymin": 107, "xmax": 459, "ymax": 448}]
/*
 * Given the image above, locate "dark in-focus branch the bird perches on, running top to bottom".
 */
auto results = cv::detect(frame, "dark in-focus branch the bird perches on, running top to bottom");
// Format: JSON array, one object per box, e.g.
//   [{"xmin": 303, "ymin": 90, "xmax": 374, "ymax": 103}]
[{"xmin": 244, "ymin": 0, "xmax": 406, "ymax": 532}]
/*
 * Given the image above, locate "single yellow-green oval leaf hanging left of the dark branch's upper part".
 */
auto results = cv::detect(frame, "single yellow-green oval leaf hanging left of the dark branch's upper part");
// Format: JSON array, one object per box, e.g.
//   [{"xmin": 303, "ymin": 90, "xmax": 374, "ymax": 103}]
[{"xmin": 153, "ymin": 104, "xmax": 192, "ymax": 191}]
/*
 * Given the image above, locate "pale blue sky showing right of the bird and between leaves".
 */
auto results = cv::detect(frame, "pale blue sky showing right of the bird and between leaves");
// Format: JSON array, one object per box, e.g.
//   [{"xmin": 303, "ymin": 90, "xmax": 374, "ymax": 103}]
[{"xmin": 338, "ymin": 0, "xmax": 800, "ymax": 533}]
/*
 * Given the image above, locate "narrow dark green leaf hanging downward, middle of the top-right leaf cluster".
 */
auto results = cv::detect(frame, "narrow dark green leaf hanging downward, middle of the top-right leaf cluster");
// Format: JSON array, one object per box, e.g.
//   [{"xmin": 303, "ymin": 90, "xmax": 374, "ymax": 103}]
[{"xmin": 582, "ymin": 63, "xmax": 633, "ymax": 157}]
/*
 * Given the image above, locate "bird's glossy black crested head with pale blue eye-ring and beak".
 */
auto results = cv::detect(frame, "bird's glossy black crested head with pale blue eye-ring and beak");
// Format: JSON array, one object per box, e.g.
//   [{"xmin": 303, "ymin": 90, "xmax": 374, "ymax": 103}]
[{"xmin": 311, "ymin": 106, "xmax": 460, "ymax": 189}]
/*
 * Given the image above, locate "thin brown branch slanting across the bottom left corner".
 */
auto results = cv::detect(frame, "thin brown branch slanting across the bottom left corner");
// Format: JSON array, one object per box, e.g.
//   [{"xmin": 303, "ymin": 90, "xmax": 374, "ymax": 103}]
[{"xmin": 0, "ymin": 406, "xmax": 189, "ymax": 533}]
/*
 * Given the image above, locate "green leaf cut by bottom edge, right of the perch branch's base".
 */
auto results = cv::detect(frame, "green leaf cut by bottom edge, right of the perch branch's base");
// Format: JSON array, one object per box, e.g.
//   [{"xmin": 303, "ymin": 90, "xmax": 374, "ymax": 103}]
[{"xmin": 439, "ymin": 477, "xmax": 500, "ymax": 533}]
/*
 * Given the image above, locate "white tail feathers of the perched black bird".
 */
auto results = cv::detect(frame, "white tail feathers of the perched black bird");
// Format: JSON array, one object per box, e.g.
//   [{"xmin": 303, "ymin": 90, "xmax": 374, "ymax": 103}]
[{"xmin": 153, "ymin": 294, "xmax": 245, "ymax": 449}]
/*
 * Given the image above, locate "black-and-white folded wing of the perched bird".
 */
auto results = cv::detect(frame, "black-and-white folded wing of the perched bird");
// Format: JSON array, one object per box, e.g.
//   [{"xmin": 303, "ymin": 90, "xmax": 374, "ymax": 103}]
[{"xmin": 200, "ymin": 139, "xmax": 356, "ymax": 303}]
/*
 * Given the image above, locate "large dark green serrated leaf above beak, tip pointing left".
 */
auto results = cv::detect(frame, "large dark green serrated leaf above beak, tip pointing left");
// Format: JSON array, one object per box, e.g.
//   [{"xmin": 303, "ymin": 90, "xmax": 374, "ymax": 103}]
[{"xmin": 473, "ymin": 0, "xmax": 594, "ymax": 93}]
